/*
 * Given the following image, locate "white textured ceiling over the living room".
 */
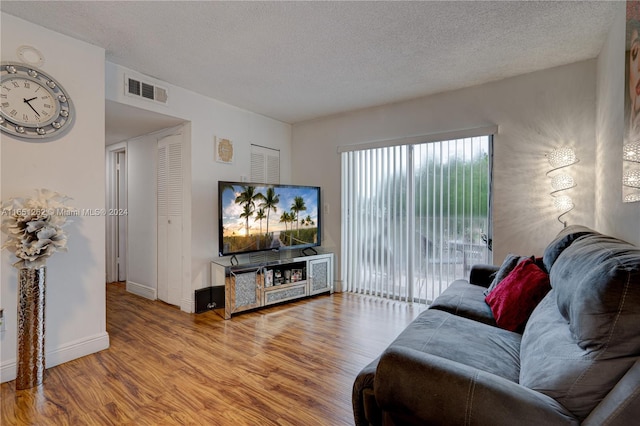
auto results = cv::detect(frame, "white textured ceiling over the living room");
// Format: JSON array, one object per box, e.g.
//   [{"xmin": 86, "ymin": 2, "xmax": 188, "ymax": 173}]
[{"xmin": 0, "ymin": 0, "xmax": 615, "ymax": 123}]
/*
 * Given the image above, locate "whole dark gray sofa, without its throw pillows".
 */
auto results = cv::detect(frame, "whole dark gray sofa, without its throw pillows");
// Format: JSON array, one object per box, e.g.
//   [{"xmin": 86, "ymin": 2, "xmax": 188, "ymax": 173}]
[{"xmin": 353, "ymin": 226, "xmax": 640, "ymax": 425}]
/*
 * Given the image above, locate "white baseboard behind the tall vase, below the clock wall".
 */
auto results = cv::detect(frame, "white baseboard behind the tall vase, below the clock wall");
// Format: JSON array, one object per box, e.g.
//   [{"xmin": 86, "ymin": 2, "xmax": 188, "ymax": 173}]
[{"xmin": 0, "ymin": 332, "xmax": 109, "ymax": 383}]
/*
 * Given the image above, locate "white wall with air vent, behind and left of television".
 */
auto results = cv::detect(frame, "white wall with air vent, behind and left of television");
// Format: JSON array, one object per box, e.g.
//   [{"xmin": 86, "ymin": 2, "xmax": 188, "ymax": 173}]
[{"xmin": 106, "ymin": 62, "xmax": 291, "ymax": 312}]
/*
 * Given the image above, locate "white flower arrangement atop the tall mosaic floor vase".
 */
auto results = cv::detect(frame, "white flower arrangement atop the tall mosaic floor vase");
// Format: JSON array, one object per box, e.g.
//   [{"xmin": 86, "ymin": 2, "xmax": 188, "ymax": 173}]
[{"xmin": 1, "ymin": 189, "xmax": 73, "ymax": 268}]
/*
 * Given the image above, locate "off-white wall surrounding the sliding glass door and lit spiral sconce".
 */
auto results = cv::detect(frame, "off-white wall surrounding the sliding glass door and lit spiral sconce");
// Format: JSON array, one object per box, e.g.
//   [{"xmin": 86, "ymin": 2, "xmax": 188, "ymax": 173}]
[{"xmin": 292, "ymin": 60, "xmax": 596, "ymax": 282}]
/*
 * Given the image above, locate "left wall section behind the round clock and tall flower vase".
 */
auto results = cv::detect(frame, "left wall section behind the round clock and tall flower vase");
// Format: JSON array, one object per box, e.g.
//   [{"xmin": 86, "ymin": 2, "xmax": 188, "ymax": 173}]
[{"xmin": 0, "ymin": 13, "xmax": 109, "ymax": 382}]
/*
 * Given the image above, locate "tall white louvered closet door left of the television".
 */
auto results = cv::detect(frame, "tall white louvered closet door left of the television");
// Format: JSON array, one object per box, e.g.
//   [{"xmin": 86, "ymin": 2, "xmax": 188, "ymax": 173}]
[{"xmin": 157, "ymin": 135, "xmax": 182, "ymax": 306}]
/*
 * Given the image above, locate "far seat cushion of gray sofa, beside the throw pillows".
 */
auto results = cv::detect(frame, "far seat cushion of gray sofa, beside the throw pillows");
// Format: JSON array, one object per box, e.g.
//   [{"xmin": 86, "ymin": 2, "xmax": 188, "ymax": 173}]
[{"xmin": 429, "ymin": 280, "xmax": 497, "ymax": 326}]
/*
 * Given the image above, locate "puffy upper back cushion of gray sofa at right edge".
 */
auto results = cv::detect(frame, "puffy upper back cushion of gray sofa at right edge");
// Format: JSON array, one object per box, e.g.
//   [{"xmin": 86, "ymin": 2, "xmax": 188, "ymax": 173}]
[{"xmin": 551, "ymin": 235, "xmax": 640, "ymax": 350}]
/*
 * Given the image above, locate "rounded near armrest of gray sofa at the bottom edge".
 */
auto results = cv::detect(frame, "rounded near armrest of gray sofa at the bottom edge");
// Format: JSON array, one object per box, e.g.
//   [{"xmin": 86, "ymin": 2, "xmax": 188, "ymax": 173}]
[{"xmin": 374, "ymin": 347, "xmax": 579, "ymax": 426}]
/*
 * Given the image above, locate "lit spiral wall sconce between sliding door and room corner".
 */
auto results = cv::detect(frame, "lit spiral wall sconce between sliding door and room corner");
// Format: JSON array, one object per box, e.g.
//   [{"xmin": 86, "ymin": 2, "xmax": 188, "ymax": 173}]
[{"xmin": 547, "ymin": 147, "xmax": 579, "ymax": 227}]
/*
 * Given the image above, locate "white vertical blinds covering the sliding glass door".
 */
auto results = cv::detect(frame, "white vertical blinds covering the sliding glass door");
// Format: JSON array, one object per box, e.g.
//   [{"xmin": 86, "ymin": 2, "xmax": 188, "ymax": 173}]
[{"xmin": 341, "ymin": 135, "xmax": 492, "ymax": 303}]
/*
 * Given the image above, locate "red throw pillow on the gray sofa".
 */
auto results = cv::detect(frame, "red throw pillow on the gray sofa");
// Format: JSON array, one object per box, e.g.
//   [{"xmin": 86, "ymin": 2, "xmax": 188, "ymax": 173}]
[{"xmin": 484, "ymin": 259, "xmax": 551, "ymax": 331}]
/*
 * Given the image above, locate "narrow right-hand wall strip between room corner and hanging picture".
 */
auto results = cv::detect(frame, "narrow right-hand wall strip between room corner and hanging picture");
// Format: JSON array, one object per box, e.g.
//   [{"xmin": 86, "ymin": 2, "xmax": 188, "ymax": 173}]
[{"xmin": 596, "ymin": 2, "xmax": 640, "ymax": 247}]
